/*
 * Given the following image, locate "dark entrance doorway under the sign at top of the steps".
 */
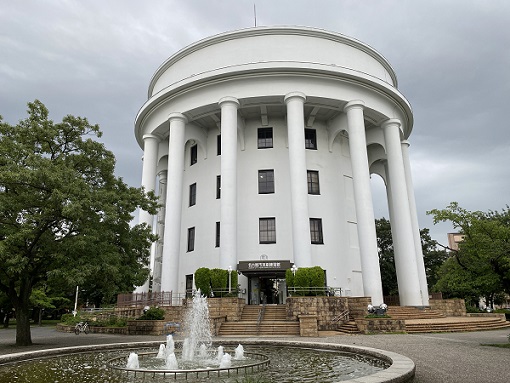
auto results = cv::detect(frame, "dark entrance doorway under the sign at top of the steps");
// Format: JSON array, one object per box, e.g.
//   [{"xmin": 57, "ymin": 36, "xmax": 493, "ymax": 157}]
[{"xmin": 248, "ymin": 276, "xmax": 287, "ymax": 305}]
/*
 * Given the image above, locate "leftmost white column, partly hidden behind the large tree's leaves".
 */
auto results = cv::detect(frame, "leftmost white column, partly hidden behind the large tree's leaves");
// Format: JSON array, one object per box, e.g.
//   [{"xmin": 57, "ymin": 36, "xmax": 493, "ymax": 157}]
[{"xmin": 135, "ymin": 134, "xmax": 159, "ymax": 293}]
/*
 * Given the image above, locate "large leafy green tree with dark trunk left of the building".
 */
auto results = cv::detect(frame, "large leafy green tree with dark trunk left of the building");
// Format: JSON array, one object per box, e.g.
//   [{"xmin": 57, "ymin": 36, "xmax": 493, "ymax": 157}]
[{"xmin": 0, "ymin": 100, "xmax": 157, "ymax": 345}]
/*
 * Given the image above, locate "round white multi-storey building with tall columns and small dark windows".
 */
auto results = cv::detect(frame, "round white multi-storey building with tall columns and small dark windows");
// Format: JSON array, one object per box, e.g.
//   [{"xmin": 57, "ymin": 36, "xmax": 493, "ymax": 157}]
[{"xmin": 135, "ymin": 27, "xmax": 428, "ymax": 306}]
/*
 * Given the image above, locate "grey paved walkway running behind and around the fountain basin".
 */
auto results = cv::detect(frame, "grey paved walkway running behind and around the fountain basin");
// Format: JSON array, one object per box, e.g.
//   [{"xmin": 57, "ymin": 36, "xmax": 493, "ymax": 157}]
[{"xmin": 0, "ymin": 327, "xmax": 510, "ymax": 383}]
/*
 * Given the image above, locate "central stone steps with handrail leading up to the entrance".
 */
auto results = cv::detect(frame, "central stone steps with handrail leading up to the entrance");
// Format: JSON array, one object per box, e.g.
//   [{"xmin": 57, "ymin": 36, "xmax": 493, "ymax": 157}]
[{"xmin": 218, "ymin": 305, "xmax": 299, "ymax": 336}]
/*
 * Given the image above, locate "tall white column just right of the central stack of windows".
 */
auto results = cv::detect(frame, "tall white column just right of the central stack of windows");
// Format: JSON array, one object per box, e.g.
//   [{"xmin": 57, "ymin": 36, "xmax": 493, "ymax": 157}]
[{"xmin": 285, "ymin": 92, "xmax": 313, "ymax": 267}]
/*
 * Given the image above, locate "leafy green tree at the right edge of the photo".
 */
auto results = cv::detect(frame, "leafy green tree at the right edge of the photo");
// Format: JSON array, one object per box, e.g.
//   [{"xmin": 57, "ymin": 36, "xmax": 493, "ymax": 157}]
[{"xmin": 427, "ymin": 202, "xmax": 510, "ymax": 304}]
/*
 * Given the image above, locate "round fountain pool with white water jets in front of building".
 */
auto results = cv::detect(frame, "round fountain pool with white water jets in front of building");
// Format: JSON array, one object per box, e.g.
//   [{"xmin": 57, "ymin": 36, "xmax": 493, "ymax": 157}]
[{"xmin": 0, "ymin": 293, "xmax": 414, "ymax": 383}]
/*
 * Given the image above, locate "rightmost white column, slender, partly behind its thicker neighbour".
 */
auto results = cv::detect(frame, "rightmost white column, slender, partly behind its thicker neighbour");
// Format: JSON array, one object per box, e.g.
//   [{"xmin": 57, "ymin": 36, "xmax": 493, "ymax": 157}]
[{"xmin": 401, "ymin": 140, "xmax": 429, "ymax": 306}]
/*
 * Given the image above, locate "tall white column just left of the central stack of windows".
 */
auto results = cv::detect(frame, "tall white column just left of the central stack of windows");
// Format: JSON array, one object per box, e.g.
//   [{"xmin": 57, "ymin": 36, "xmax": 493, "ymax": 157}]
[{"xmin": 218, "ymin": 97, "xmax": 239, "ymax": 270}]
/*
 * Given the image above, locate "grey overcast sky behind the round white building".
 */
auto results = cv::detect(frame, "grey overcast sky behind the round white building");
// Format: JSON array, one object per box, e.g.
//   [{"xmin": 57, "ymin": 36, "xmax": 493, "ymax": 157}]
[{"xmin": 0, "ymin": 0, "xmax": 510, "ymax": 244}]
